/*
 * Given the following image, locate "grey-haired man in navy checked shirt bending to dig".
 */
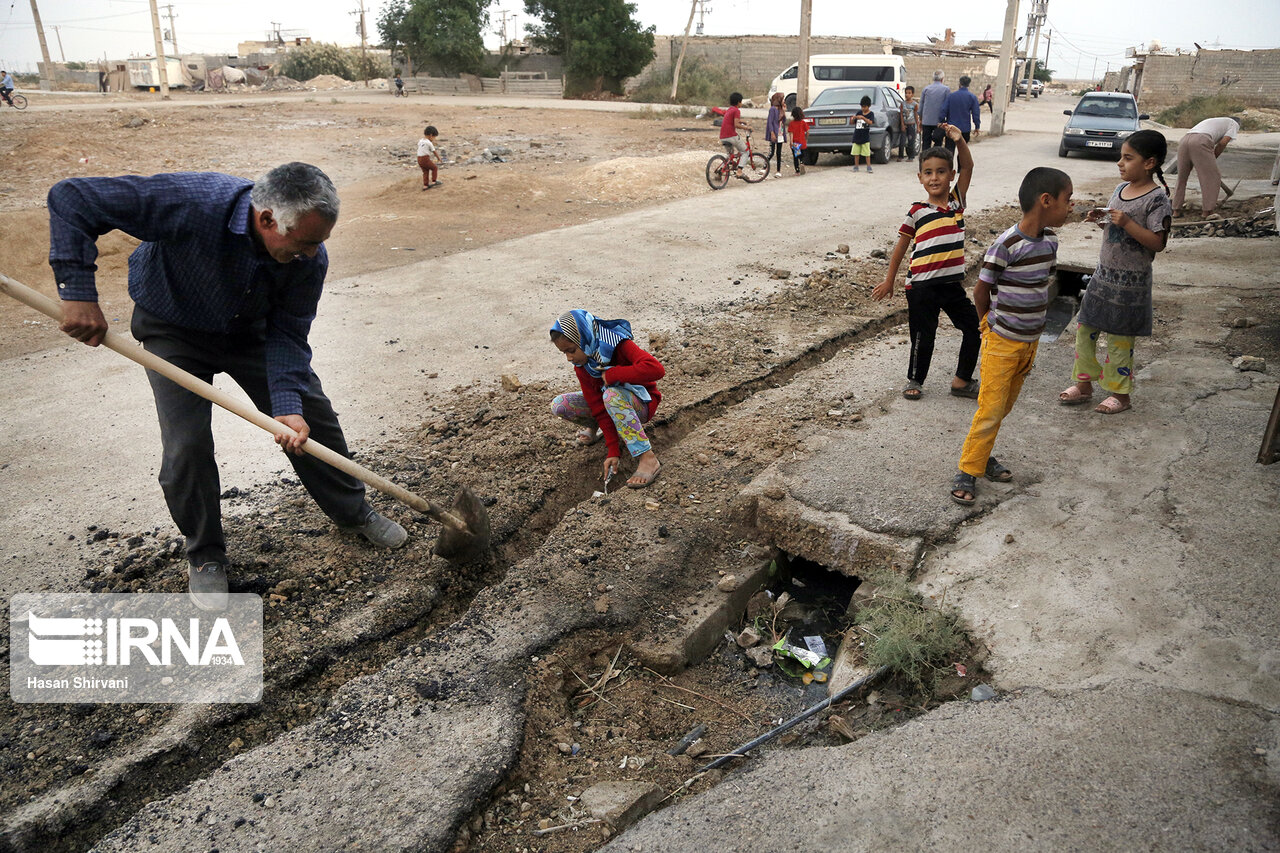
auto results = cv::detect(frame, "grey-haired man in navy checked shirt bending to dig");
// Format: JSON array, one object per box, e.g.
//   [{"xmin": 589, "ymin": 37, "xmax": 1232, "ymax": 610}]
[{"xmin": 49, "ymin": 163, "xmax": 407, "ymax": 610}]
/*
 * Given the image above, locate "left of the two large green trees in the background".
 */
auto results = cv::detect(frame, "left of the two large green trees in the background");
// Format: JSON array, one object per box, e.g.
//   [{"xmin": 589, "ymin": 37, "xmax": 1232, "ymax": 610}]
[{"xmin": 378, "ymin": 0, "xmax": 489, "ymax": 74}]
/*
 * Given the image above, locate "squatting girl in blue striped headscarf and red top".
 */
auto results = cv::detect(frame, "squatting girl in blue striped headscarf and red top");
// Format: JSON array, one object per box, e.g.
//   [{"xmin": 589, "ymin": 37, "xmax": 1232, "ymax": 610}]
[{"xmin": 550, "ymin": 309, "xmax": 666, "ymax": 489}]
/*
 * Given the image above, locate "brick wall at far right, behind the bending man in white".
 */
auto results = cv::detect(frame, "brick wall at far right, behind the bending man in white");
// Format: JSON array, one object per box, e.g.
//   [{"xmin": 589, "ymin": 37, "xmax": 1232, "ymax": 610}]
[{"xmin": 1139, "ymin": 50, "xmax": 1280, "ymax": 110}]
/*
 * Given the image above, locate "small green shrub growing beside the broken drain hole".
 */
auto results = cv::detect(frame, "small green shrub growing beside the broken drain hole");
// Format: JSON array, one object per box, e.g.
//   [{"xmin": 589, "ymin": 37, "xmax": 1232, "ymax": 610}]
[{"xmin": 855, "ymin": 570, "xmax": 965, "ymax": 688}]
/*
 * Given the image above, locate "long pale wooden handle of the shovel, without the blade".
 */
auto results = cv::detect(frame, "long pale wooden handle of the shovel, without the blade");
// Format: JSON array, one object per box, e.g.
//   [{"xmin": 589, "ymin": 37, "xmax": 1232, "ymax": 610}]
[{"xmin": 0, "ymin": 274, "xmax": 471, "ymax": 534}]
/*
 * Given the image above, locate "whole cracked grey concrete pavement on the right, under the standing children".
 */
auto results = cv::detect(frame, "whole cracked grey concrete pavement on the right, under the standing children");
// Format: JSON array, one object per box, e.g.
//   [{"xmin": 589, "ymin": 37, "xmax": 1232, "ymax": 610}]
[{"xmin": 614, "ymin": 229, "xmax": 1280, "ymax": 852}]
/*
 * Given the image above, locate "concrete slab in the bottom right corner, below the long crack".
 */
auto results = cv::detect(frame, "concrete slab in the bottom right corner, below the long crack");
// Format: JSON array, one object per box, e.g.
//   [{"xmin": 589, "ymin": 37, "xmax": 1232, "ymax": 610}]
[{"xmin": 602, "ymin": 684, "xmax": 1280, "ymax": 853}]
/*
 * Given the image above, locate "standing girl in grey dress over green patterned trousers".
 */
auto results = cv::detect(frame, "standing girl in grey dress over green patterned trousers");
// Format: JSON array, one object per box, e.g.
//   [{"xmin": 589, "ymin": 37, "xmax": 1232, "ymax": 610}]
[{"xmin": 1057, "ymin": 131, "xmax": 1174, "ymax": 415}]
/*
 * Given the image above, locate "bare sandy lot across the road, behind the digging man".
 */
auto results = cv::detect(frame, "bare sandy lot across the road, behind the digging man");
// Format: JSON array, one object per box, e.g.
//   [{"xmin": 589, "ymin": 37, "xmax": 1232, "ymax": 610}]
[{"xmin": 0, "ymin": 95, "xmax": 716, "ymax": 359}]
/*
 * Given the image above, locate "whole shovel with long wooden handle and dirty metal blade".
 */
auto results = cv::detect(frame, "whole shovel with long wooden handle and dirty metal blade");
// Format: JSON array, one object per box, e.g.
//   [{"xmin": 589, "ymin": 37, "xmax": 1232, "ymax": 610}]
[{"xmin": 0, "ymin": 275, "xmax": 489, "ymax": 564}]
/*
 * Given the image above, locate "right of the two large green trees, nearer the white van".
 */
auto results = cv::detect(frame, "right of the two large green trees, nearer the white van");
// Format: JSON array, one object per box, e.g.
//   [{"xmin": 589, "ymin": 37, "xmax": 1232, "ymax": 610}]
[{"xmin": 525, "ymin": 0, "xmax": 654, "ymax": 91}]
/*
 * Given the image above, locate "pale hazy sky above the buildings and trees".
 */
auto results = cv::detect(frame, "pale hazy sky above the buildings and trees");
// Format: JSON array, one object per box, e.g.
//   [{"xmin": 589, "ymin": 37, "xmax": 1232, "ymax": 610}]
[{"xmin": 0, "ymin": 0, "xmax": 1280, "ymax": 77}]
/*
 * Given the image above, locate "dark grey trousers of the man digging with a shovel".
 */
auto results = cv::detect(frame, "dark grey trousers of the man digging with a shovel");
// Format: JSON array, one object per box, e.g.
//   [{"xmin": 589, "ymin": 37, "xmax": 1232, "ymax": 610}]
[{"xmin": 131, "ymin": 307, "xmax": 371, "ymax": 565}]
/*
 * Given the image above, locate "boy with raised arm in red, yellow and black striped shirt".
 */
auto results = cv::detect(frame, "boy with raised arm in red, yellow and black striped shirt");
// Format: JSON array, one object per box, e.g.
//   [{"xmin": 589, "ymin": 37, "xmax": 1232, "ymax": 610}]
[{"xmin": 872, "ymin": 124, "xmax": 982, "ymax": 400}]
